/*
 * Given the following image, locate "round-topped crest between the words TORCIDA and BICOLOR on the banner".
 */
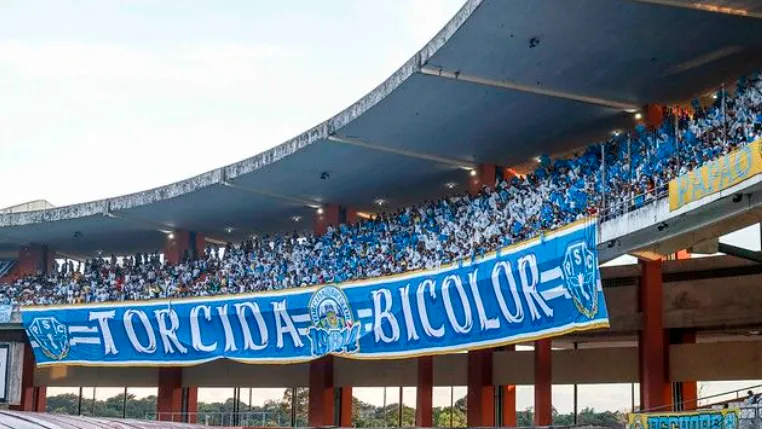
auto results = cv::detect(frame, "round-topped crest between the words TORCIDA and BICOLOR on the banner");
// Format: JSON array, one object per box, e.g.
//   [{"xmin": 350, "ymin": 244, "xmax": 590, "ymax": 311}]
[{"xmin": 309, "ymin": 286, "xmax": 360, "ymax": 356}]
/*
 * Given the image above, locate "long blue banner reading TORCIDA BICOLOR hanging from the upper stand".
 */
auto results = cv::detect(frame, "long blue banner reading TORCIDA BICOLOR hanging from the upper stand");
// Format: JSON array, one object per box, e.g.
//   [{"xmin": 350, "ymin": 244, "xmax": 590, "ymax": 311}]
[{"xmin": 22, "ymin": 220, "xmax": 608, "ymax": 366}]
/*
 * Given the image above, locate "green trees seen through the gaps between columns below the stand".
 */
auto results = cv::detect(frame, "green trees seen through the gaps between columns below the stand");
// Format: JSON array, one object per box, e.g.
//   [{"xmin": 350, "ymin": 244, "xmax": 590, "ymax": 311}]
[{"xmin": 47, "ymin": 388, "xmax": 626, "ymax": 428}]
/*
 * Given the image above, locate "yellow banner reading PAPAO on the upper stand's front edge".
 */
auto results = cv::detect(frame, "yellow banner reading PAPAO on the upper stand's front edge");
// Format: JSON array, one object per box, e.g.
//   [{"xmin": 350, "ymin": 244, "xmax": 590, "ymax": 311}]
[{"xmin": 669, "ymin": 140, "xmax": 762, "ymax": 211}]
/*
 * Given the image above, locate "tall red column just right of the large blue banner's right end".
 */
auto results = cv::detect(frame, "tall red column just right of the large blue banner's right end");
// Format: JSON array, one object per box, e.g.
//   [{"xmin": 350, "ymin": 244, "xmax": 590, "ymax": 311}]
[{"xmin": 638, "ymin": 260, "xmax": 670, "ymax": 411}]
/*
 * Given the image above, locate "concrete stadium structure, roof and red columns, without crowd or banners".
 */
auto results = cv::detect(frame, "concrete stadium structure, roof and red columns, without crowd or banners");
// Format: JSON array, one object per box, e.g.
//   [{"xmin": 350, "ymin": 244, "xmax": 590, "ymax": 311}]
[{"xmin": 0, "ymin": 0, "xmax": 762, "ymax": 427}]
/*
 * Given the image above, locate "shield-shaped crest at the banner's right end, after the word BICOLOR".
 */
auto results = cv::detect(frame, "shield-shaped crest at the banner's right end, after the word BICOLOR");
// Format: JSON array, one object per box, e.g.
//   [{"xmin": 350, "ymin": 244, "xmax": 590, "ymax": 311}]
[{"xmin": 563, "ymin": 241, "xmax": 598, "ymax": 319}]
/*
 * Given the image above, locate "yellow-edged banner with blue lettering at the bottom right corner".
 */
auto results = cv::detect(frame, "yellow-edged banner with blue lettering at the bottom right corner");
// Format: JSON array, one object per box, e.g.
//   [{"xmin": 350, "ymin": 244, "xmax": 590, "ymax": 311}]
[{"xmin": 627, "ymin": 408, "xmax": 740, "ymax": 429}]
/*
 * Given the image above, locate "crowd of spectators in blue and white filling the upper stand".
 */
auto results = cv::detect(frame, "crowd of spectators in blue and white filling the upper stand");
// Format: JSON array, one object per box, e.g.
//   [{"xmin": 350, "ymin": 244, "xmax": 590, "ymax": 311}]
[{"xmin": 0, "ymin": 75, "xmax": 762, "ymax": 305}]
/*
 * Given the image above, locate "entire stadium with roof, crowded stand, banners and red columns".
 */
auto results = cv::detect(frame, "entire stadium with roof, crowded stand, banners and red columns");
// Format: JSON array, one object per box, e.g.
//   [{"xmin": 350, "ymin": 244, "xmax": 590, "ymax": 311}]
[{"xmin": 0, "ymin": 0, "xmax": 762, "ymax": 428}]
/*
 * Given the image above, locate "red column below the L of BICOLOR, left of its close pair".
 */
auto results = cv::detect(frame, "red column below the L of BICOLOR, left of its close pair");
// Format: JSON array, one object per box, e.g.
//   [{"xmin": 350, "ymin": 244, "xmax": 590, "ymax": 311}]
[{"xmin": 466, "ymin": 349, "xmax": 495, "ymax": 427}]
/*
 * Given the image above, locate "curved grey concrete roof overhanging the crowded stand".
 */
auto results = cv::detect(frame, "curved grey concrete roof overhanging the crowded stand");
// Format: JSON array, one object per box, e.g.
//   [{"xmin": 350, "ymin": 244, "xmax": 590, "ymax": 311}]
[{"xmin": 0, "ymin": 0, "xmax": 762, "ymax": 256}]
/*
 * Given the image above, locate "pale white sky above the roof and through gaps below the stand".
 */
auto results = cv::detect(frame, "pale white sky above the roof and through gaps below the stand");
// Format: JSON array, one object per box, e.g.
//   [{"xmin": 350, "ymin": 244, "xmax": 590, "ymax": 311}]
[{"xmin": 8, "ymin": 0, "xmax": 760, "ymax": 412}]
